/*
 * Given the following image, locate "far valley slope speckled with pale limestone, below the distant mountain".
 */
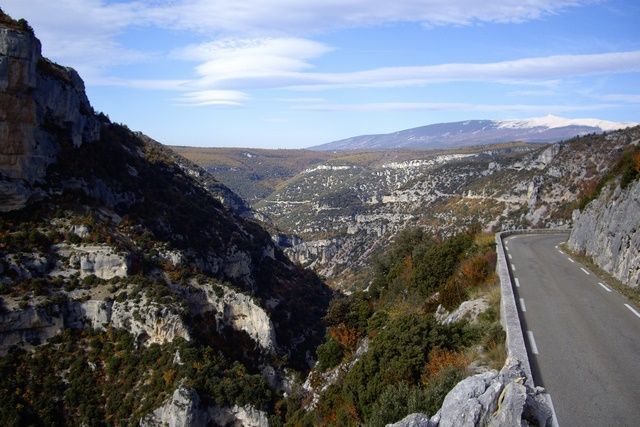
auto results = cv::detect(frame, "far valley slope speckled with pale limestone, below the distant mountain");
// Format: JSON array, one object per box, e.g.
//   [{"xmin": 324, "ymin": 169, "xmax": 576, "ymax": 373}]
[{"xmin": 179, "ymin": 127, "xmax": 640, "ymax": 290}]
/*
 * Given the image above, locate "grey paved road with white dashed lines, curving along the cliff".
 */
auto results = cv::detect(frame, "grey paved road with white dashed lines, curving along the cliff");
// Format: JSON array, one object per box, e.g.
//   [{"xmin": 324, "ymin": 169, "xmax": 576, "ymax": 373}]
[{"xmin": 505, "ymin": 234, "xmax": 640, "ymax": 427}]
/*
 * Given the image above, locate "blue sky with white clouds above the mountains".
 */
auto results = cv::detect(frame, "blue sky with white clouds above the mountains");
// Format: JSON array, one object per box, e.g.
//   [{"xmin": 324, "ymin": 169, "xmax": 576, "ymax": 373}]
[{"xmin": 0, "ymin": 0, "xmax": 640, "ymax": 148}]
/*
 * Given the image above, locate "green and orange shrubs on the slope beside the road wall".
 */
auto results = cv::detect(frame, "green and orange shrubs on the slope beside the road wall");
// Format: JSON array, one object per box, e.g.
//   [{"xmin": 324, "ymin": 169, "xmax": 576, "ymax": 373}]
[{"xmin": 271, "ymin": 229, "xmax": 504, "ymax": 426}]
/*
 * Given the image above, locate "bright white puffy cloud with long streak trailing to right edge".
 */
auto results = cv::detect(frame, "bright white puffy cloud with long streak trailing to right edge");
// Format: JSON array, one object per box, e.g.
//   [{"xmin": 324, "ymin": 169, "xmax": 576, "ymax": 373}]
[{"xmin": 178, "ymin": 47, "xmax": 640, "ymax": 90}]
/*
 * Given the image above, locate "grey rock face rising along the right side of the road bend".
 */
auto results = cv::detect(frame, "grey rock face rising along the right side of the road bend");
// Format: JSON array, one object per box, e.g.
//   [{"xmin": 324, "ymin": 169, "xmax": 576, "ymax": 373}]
[{"xmin": 568, "ymin": 180, "xmax": 640, "ymax": 287}]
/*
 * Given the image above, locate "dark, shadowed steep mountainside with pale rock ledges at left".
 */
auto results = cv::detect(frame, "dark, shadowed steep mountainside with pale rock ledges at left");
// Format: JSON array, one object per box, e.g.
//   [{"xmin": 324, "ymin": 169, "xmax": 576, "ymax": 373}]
[{"xmin": 0, "ymin": 11, "xmax": 333, "ymax": 425}]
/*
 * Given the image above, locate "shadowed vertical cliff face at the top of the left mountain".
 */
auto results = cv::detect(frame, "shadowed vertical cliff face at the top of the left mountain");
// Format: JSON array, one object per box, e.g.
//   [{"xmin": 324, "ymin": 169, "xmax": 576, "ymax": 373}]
[{"xmin": 0, "ymin": 23, "xmax": 100, "ymax": 212}]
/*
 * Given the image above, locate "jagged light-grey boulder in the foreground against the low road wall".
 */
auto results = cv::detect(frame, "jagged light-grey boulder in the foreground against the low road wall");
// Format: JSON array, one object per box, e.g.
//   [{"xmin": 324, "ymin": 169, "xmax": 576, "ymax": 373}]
[{"xmin": 389, "ymin": 358, "xmax": 552, "ymax": 427}]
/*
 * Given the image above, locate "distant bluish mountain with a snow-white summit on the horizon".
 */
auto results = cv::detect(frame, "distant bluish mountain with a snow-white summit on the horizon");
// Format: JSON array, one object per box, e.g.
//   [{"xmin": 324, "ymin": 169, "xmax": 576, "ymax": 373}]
[{"xmin": 311, "ymin": 115, "xmax": 635, "ymax": 151}]
